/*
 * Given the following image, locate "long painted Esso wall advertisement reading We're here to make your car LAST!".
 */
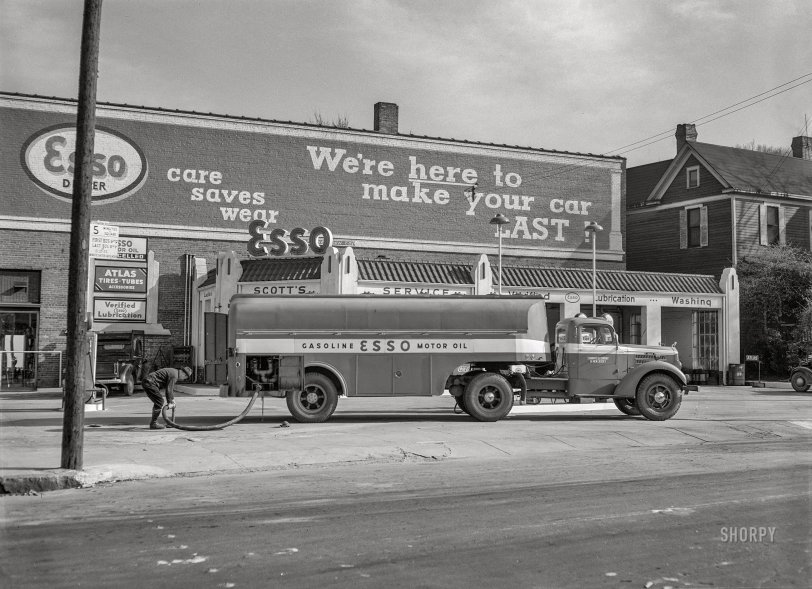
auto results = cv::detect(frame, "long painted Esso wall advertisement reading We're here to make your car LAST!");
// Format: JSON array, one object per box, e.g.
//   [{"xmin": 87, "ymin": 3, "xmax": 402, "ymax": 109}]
[{"xmin": 0, "ymin": 99, "xmax": 623, "ymax": 250}]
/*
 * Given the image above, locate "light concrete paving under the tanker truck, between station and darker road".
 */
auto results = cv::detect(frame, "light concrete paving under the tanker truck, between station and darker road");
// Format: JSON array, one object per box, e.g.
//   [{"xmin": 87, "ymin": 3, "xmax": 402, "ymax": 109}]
[{"xmin": 0, "ymin": 383, "xmax": 800, "ymax": 494}]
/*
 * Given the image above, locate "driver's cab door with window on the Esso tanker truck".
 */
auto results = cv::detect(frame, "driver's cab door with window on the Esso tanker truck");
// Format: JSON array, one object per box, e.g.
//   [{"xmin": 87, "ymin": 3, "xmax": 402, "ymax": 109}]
[{"xmin": 570, "ymin": 323, "xmax": 619, "ymax": 395}]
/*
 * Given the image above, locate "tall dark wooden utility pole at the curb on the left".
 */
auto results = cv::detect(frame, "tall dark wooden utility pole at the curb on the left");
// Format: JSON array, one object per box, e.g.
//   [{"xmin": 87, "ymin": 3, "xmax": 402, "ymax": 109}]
[{"xmin": 60, "ymin": 0, "xmax": 102, "ymax": 470}]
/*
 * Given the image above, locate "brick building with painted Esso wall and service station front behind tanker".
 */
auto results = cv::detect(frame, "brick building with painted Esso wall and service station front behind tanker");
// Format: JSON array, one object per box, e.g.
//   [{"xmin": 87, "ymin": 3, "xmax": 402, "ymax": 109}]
[{"xmin": 0, "ymin": 93, "xmax": 738, "ymax": 386}]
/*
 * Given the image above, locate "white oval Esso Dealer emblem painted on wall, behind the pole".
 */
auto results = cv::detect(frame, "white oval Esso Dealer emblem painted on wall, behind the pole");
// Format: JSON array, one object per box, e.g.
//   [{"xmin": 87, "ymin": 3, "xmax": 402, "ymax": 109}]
[{"xmin": 21, "ymin": 125, "xmax": 147, "ymax": 204}]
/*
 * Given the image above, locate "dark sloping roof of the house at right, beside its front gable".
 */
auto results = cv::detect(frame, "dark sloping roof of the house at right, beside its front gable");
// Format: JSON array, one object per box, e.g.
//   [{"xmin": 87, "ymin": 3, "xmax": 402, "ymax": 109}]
[{"xmin": 688, "ymin": 142, "xmax": 812, "ymax": 196}]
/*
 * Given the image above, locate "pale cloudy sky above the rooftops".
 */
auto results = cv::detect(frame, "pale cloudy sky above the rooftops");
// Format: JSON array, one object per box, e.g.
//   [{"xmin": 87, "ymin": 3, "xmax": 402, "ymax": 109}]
[{"xmin": 0, "ymin": 0, "xmax": 812, "ymax": 166}]
